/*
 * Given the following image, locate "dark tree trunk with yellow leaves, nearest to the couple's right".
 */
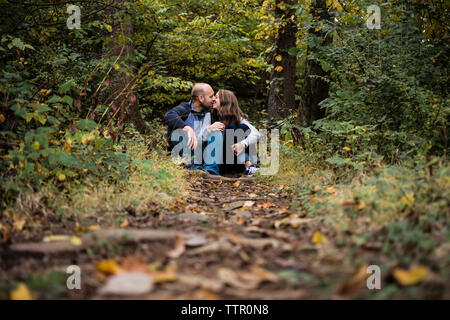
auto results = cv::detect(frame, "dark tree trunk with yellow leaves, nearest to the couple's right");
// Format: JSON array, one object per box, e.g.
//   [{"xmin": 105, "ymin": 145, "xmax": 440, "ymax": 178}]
[{"xmin": 268, "ymin": 0, "xmax": 297, "ymax": 120}]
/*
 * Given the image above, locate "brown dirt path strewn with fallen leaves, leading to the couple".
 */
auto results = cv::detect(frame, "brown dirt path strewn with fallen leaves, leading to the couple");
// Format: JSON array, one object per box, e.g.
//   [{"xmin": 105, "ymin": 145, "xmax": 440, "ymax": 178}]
[{"xmin": 0, "ymin": 172, "xmax": 378, "ymax": 299}]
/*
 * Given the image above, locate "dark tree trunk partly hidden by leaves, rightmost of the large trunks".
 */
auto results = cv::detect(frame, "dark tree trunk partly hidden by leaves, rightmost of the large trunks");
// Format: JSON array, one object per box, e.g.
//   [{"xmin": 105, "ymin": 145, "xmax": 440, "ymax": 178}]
[{"xmin": 299, "ymin": 0, "xmax": 332, "ymax": 126}]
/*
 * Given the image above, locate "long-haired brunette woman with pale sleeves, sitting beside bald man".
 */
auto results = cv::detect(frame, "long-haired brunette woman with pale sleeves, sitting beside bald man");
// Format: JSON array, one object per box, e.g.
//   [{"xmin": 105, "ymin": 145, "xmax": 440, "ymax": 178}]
[{"xmin": 208, "ymin": 89, "xmax": 260, "ymax": 175}]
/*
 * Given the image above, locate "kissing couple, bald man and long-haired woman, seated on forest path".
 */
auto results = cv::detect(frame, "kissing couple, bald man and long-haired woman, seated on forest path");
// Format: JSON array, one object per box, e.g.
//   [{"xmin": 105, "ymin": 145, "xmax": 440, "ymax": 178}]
[{"xmin": 164, "ymin": 83, "xmax": 260, "ymax": 175}]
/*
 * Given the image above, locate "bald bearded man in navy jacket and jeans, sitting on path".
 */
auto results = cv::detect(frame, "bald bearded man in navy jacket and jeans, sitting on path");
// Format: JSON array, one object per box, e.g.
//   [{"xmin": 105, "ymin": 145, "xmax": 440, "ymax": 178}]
[{"xmin": 164, "ymin": 83, "xmax": 225, "ymax": 174}]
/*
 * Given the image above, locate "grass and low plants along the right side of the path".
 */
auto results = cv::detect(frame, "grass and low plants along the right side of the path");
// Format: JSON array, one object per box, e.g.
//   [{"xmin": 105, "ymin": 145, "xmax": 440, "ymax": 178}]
[{"xmin": 260, "ymin": 144, "xmax": 450, "ymax": 294}]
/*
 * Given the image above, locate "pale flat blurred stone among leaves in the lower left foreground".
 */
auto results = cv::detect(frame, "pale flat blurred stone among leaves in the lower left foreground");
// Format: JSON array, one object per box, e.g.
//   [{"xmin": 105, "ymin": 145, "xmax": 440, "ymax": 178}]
[{"xmin": 99, "ymin": 272, "xmax": 153, "ymax": 296}]
